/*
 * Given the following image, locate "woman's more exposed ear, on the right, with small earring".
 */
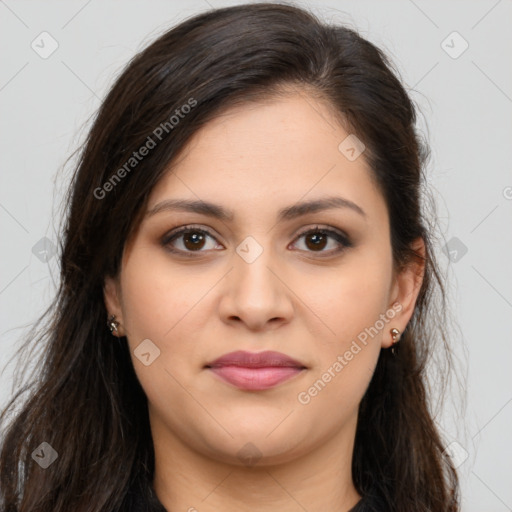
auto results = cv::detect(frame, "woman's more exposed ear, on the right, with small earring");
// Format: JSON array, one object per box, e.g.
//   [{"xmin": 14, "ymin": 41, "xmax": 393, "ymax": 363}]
[{"xmin": 382, "ymin": 238, "xmax": 426, "ymax": 348}]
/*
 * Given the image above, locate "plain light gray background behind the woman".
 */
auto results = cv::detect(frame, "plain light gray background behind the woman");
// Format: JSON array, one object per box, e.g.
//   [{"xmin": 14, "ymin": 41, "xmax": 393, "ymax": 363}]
[{"xmin": 0, "ymin": 0, "xmax": 512, "ymax": 512}]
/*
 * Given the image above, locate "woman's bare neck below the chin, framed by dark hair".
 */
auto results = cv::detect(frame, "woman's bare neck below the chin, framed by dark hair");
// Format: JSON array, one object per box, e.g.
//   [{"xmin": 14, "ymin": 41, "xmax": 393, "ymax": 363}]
[{"xmin": 151, "ymin": 412, "xmax": 360, "ymax": 512}]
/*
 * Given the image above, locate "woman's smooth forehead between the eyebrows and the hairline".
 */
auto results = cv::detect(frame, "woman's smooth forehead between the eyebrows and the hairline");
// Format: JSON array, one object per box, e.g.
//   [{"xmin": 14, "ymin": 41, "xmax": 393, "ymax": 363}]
[{"xmin": 148, "ymin": 94, "xmax": 385, "ymax": 224}]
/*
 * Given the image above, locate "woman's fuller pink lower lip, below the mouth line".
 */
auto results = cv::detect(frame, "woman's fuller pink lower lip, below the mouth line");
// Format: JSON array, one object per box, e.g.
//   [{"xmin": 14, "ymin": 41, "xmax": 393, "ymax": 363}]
[{"xmin": 209, "ymin": 366, "xmax": 302, "ymax": 391}]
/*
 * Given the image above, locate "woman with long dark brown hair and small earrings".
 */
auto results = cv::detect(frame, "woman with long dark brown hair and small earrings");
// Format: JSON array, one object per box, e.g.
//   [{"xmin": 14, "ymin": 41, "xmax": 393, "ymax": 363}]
[{"xmin": 0, "ymin": 3, "xmax": 459, "ymax": 512}]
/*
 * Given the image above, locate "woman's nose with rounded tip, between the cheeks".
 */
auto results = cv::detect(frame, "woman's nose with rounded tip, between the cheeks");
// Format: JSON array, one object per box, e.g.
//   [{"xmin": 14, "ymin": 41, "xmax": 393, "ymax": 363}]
[{"xmin": 219, "ymin": 245, "xmax": 294, "ymax": 331}]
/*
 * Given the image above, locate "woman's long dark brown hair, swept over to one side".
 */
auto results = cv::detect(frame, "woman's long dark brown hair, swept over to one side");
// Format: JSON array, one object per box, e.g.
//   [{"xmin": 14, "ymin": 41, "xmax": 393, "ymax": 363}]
[{"xmin": 0, "ymin": 3, "xmax": 459, "ymax": 512}]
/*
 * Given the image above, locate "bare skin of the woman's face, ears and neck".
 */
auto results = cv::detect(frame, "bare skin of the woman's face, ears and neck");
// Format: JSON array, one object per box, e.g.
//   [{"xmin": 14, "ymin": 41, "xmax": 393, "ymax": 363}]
[{"xmin": 104, "ymin": 92, "xmax": 424, "ymax": 512}]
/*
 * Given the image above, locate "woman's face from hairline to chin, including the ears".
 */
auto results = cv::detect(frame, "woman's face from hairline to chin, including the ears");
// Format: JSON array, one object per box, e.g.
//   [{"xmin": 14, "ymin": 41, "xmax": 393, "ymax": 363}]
[{"xmin": 105, "ymin": 91, "xmax": 419, "ymax": 465}]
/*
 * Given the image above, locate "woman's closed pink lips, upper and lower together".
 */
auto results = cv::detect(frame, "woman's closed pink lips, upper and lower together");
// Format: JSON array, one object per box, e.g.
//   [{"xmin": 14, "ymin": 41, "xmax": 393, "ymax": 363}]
[{"xmin": 206, "ymin": 350, "xmax": 306, "ymax": 391}]
